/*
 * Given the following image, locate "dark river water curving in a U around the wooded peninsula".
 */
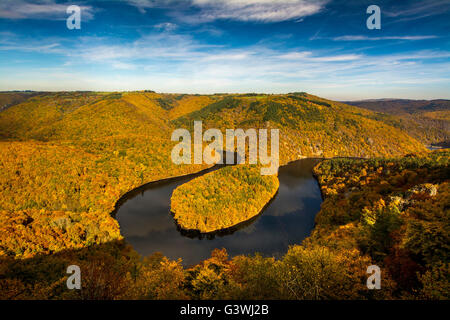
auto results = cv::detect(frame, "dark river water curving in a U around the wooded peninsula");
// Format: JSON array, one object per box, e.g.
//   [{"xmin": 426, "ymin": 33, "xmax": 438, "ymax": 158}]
[{"xmin": 116, "ymin": 159, "xmax": 322, "ymax": 265}]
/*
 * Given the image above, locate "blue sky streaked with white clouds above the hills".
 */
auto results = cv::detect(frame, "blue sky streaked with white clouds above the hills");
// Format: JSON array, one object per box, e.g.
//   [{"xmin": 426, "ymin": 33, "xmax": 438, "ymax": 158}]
[{"xmin": 0, "ymin": 0, "xmax": 450, "ymax": 100}]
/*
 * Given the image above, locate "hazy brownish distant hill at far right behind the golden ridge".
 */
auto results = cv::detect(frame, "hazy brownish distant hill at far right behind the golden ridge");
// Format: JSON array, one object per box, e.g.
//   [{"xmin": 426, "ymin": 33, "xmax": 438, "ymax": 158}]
[{"xmin": 345, "ymin": 99, "xmax": 450, "ymax": 147}]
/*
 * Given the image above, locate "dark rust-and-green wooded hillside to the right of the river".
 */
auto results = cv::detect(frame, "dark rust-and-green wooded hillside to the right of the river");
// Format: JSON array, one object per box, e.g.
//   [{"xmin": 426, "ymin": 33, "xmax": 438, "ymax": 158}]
[{"xmin": 308, "ymin": 151, "xmax": 450, "ymax": 299}]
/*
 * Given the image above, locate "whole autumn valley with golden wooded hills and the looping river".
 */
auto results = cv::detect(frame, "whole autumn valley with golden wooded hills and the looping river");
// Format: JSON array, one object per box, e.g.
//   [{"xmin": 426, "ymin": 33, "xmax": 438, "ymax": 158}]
[{"xmin": 0, "ymin": 91, "xmax": 449, "ymax": 299}]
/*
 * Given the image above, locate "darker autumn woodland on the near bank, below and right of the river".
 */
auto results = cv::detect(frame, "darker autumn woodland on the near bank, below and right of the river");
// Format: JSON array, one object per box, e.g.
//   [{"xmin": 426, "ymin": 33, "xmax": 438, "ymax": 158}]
[{"xmin": 0, "ymin": 152, "xmax": 450, "ymax": 299}]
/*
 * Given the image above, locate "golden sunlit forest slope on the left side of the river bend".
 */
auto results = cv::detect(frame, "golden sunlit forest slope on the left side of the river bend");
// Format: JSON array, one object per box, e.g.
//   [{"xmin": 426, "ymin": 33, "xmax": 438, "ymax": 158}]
[{"xmin": 0, "ymin": 93, "xmax": 213, "ymax": 257}]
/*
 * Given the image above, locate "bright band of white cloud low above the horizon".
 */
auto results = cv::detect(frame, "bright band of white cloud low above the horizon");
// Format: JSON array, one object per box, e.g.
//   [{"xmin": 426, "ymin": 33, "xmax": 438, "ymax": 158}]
[{"xmin": 0, "ymin": 32, "xmax": 450, "ymax": 99}]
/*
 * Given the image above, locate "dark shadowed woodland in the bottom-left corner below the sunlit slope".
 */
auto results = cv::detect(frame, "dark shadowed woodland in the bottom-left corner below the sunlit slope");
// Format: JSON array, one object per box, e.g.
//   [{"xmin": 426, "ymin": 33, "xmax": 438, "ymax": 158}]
[{"xmin": 0, "ymin": 241, "xmax": 151, "ymax": 300}]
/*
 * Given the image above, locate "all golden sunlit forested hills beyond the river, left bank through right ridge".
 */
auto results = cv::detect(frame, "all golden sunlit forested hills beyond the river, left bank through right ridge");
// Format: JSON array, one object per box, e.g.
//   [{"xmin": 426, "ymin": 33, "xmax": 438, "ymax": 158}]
[{"xmin": 0, "ymin": 92, "xmax": 423, "ymax": 256}]
